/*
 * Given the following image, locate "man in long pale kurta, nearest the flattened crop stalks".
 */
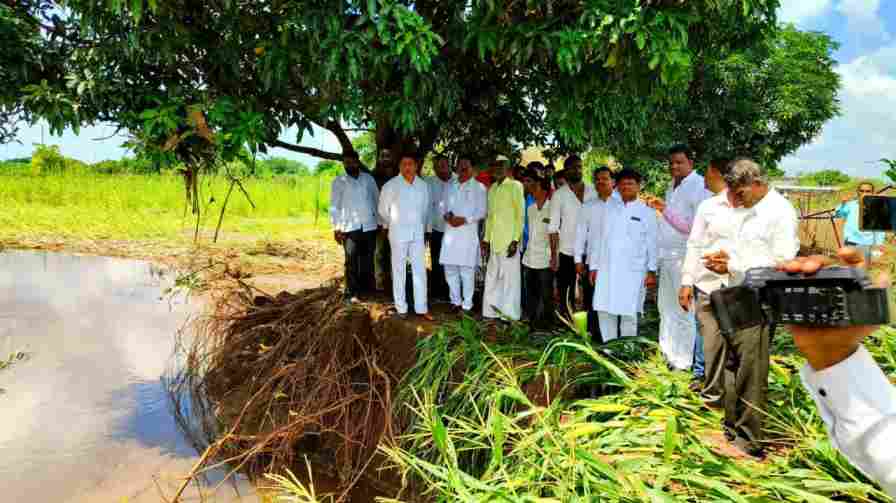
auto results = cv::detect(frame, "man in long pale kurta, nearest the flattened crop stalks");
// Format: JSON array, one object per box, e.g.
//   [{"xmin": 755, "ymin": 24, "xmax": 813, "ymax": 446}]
[{"xmin": 594, "ymin": 169, "xmax": 657, "ymax": 341}]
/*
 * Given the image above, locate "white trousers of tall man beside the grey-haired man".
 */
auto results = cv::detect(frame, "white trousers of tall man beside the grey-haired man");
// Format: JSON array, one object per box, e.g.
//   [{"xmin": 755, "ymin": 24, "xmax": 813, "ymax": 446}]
[{"xmin": 656, "ymin": 257, "xmax": 697, "ymax": 370}]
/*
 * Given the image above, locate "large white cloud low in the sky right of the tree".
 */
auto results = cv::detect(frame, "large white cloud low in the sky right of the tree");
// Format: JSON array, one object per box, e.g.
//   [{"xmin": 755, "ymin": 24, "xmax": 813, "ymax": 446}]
[{"xmin": 782, "ymin": 45, "xmax": 896, "ymax": 176}]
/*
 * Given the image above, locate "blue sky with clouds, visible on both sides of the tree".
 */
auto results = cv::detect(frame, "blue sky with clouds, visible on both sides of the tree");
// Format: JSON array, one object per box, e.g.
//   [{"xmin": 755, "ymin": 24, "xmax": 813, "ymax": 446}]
[{"xmin": 0, "ymin": 0, "xmax": 896, "ymax": 176}]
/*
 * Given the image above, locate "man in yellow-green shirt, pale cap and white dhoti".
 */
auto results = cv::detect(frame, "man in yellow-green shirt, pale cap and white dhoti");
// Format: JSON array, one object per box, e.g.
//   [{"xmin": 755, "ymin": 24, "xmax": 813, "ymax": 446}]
[{"xmin": 482, "ymin": 161, "xmax": 525, "ymax": 320}]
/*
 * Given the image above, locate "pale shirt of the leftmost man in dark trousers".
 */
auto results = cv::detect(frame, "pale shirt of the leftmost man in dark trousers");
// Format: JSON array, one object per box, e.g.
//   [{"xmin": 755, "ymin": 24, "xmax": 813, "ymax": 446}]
[{"xmin": 330, "ymin": 171, "xmax": 379, "ymax": 232}]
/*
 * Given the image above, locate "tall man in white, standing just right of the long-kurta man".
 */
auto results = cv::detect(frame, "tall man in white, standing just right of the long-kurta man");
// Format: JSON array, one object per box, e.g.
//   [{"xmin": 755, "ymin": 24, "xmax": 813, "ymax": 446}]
[{"xmin": 656, "ymin": 145, "xmax": 711, "ymax": 370}]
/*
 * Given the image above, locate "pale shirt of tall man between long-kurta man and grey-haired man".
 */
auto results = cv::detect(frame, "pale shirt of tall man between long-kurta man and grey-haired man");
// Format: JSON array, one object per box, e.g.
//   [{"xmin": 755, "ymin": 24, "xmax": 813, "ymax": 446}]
[{"xmin": 657, "ymin": 171, "xmax": 712, "ymax": 259}]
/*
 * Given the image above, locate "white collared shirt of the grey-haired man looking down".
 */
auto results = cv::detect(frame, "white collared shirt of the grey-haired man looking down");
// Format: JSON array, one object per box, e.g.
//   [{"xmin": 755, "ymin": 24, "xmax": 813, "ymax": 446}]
[{"xmin": 726, "ymin": 188, "xmax": 800, "ymax": 285}]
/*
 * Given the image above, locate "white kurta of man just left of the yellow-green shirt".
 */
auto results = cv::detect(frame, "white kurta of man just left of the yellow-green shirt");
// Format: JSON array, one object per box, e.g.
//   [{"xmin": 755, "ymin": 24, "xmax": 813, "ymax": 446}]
[{"xmin": 439, "ymin": 178, "xmax": 488, "ymax": 267}]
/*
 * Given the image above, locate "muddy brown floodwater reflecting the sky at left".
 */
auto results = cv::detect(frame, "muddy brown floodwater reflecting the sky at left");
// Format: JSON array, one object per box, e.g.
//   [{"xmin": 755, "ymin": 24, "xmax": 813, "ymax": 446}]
[{"xmin": 0, "ymin": 250, "xmax": 257, "ymax": 503}]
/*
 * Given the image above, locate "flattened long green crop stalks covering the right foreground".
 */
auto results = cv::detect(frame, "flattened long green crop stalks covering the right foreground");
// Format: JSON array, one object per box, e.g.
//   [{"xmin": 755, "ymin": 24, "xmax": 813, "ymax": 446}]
[{"xmin": 381, "ymin": 328, "xmax": 896, "ymax": 503}]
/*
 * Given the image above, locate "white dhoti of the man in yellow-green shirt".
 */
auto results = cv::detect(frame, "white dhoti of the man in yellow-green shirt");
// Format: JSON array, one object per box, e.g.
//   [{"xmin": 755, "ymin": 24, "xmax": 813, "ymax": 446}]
[{"xmin": 482, "ymin": 250, "xmax": 523, "ymax": 320}]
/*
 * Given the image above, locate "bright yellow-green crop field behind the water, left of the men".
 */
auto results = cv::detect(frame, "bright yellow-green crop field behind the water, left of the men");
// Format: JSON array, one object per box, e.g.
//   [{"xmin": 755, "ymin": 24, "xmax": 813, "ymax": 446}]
[{"xmin": 0, "ymin": 170, "xmax": 332, "ymax": 246}]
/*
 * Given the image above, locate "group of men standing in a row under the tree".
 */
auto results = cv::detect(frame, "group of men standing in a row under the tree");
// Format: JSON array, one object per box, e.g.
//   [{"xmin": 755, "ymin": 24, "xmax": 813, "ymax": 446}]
[{"xmin": 330, "ymin": 145, "xmax": 799, "ymax": 454}]
